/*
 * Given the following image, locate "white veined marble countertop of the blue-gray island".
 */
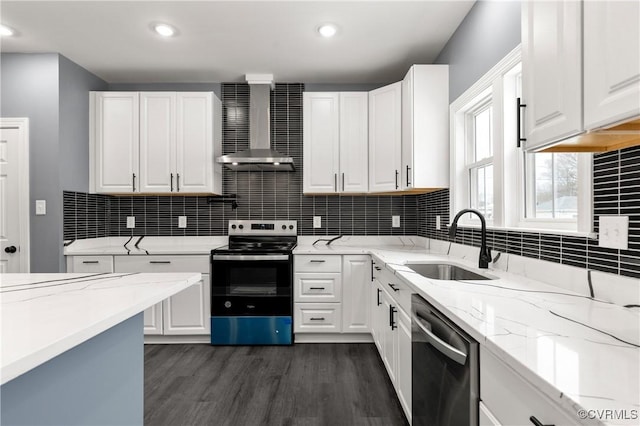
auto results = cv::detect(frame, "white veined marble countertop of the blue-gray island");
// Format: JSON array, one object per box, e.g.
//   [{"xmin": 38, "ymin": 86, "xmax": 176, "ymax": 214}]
[{"xmin": 0, "ymin": 273, "xmax": 202, "ymax": 384}]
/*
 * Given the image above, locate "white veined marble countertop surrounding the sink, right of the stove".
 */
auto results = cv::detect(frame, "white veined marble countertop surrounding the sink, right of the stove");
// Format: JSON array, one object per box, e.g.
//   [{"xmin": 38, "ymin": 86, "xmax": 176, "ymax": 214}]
[{"xmin": 294, "ymin": 244, "xmax": 640, "ymax": 425}]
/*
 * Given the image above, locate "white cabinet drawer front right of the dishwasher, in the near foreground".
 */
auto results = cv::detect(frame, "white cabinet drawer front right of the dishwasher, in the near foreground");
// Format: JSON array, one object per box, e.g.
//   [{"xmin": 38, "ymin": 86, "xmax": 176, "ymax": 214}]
[{"xmin": 480, "ymin": 347, "xmax": 581, "ymax": 426}]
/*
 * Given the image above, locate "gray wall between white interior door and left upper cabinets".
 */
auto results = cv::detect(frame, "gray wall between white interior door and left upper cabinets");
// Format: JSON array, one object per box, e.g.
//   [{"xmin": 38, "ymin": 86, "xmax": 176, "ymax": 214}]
[{"xmin": 0, "ymin": 53, "xmax": 107, "ymax": 272}]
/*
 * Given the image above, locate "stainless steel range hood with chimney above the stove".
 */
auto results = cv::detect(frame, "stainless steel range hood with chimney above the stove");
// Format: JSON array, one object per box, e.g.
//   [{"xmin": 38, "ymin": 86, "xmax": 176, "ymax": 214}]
[{"xmin": 216, "ymin": 75, "xmax": 295, "ymax": 172}]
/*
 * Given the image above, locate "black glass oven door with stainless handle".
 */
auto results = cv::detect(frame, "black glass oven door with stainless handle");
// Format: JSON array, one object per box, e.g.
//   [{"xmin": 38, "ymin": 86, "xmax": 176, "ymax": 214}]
[{"xmin": 211, "ymin": 254, "xmax": 293, "ymax": 317}]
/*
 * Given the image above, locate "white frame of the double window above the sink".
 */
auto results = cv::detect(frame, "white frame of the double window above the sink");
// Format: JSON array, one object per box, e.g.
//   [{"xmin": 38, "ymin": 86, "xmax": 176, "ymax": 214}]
[{"xmin": 449, "ymin": 46, "xmax": 593, "ymax": 236}]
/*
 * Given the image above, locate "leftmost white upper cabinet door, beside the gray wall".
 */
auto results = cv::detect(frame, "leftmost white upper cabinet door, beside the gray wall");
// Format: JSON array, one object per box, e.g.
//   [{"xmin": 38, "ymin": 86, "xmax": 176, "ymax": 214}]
[{"xmin": 90, "ymin": 92, "xmax": 139, "ymax": 193}]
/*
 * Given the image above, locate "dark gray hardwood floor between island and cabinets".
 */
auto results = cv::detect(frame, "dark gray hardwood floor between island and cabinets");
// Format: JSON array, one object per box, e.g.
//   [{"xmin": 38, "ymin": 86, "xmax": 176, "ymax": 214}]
[{"xmin": 144, "ymin": 343, "xmax": 407, "ymax": 426}]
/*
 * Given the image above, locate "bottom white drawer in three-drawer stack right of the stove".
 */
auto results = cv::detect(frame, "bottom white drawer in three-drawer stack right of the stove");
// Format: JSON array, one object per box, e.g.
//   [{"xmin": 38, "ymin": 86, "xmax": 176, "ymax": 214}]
[{"xmin": 293, "ymin": 303, "xmax": 342, "ymax": 333}]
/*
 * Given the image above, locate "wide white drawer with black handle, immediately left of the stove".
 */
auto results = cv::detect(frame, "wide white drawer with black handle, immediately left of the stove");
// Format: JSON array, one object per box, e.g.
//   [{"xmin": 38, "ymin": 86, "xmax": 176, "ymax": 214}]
[{"xmin": 114, "ymin": 256, "xmax": 209, "ymax": 274}]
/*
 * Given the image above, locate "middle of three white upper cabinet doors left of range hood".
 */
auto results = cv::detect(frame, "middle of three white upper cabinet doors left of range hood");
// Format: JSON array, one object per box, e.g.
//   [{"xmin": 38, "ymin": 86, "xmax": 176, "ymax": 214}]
[{"xmin": 140, "ymin": 92, "xmax": 176, "ymax": 193}]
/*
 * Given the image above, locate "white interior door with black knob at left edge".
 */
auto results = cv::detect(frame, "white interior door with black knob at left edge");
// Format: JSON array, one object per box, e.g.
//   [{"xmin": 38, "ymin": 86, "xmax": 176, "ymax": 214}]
[{"xmin": 0, "ymin": 119, "xmax": 29, "ymax": 273}]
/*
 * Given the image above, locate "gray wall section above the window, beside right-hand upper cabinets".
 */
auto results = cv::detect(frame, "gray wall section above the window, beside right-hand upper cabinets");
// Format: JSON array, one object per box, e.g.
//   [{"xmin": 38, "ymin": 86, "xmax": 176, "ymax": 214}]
[{"xmin": 435, "ymin": 0, "xmax": 521, "ymax": 102}]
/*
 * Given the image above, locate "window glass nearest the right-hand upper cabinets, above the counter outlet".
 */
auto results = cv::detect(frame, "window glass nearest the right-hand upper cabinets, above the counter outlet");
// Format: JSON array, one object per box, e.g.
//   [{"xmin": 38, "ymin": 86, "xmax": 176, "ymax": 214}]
[{"xmin": 526, "ymin": 153, "xmax": 578, "ymax": 219}]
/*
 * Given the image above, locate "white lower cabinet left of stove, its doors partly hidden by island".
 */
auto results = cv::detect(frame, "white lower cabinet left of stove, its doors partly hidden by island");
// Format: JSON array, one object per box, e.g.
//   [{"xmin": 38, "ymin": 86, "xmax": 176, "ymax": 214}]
[{"xmin": 114, "ymin": 255, "xmax": 211, "ymax": 335}]
